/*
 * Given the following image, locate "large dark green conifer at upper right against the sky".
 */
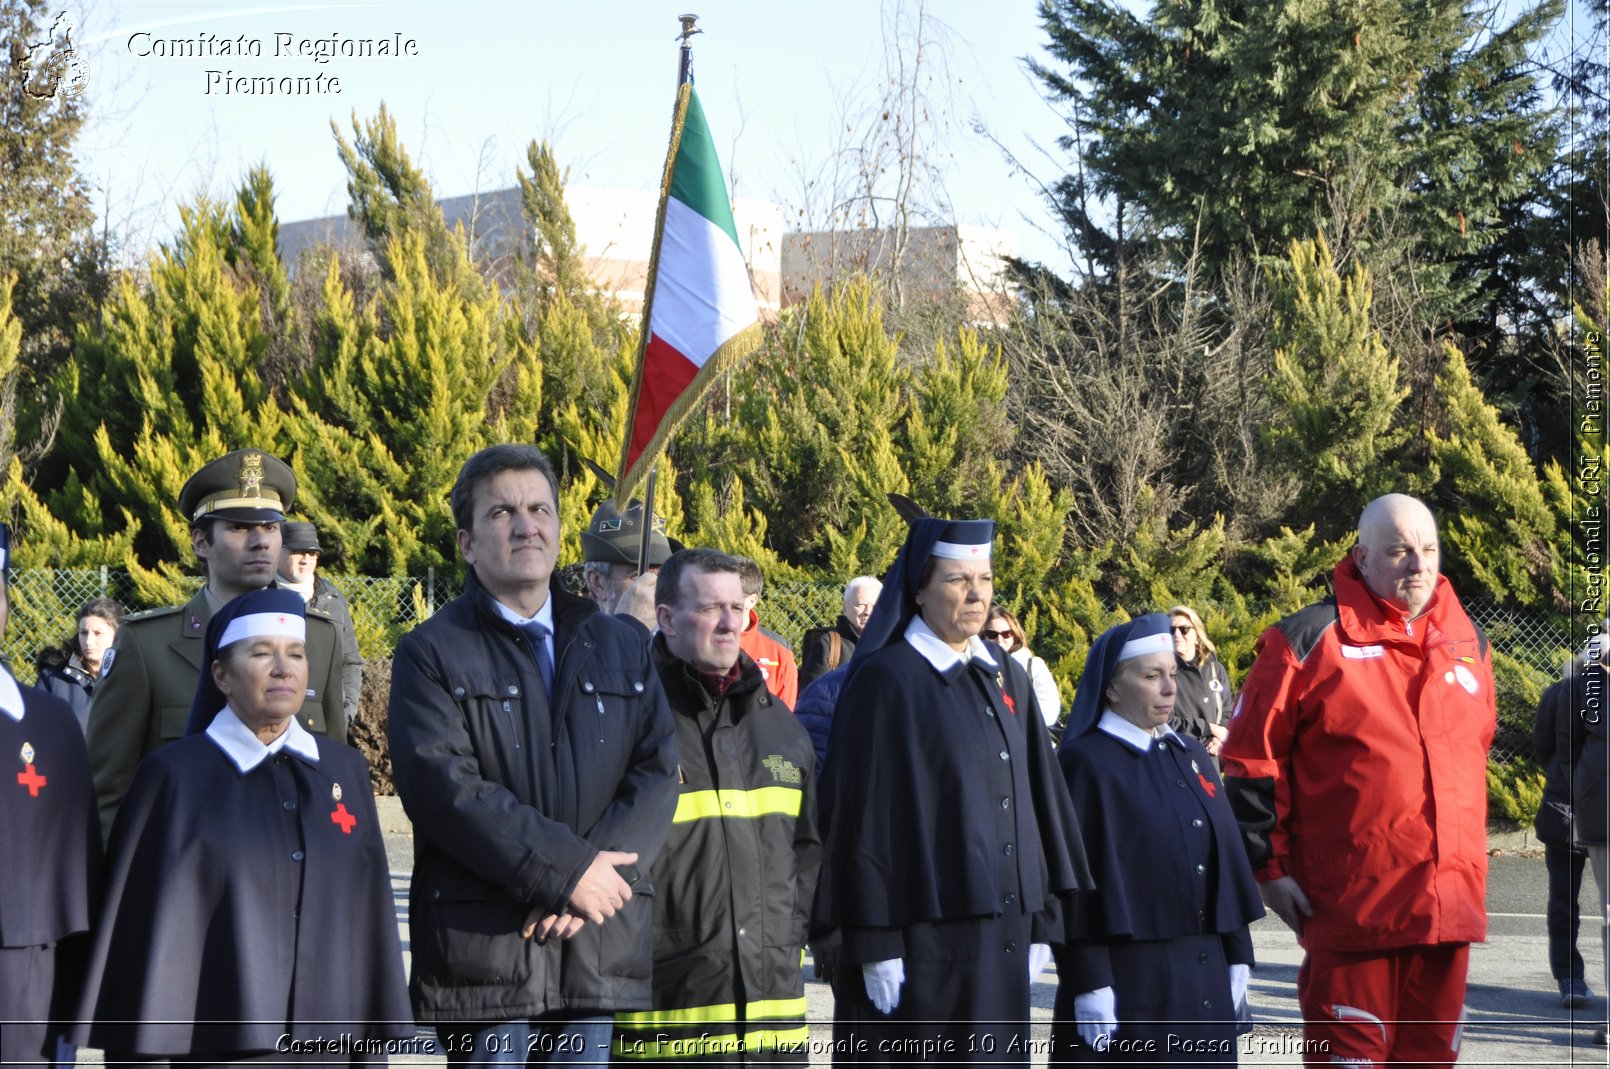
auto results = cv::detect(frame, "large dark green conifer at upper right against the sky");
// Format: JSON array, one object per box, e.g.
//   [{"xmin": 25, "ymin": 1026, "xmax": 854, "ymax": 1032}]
[{"xmin": 1030, "ymin": 0, "xmax": 1563, "ymax": 307}]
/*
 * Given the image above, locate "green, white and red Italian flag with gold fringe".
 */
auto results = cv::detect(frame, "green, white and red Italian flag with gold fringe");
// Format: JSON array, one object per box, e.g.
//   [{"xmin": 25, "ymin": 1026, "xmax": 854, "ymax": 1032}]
[{"xmin": 615, "ymin": 82, "xmax": 760, "ymax": 501}]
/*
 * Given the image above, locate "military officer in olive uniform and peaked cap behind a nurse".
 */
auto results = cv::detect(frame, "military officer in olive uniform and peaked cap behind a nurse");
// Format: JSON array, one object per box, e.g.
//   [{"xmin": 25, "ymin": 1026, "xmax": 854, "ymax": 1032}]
[{"xmin": 85, "ymin": 449, "xmax": 346, "ymax": 834}]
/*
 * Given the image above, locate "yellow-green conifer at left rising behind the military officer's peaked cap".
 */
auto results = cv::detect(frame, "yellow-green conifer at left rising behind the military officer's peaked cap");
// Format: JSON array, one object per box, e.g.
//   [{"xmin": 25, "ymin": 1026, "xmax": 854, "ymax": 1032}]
[{"xmin": 50, "ymin": 183, "xmax": 288, "ymax": 604}]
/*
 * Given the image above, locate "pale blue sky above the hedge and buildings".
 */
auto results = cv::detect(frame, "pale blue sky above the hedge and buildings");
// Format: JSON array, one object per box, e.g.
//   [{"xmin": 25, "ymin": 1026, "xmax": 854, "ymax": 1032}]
[{"xmin": 64, "ymin": 0, "xmax": 1088, "ymax": 275}]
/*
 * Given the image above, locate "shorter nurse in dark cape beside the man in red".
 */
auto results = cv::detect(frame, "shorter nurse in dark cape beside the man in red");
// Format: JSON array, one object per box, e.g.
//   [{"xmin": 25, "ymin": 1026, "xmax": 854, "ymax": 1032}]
[{"xmin": 1051, "ymin": 613, "xmax": 1264, "ymax": 1066}]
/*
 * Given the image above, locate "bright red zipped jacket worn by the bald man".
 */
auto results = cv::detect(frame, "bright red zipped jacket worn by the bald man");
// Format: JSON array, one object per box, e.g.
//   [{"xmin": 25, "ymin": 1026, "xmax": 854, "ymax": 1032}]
[{"xmin": 1222, "ymin": 557, "xmax": 1496, "ymax": 951}]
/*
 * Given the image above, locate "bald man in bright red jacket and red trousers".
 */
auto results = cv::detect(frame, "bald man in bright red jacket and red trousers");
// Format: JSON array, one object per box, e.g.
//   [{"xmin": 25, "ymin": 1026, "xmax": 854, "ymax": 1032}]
[{"xmin": 1224, "ymin": 494, "xmax": 1496, "ymax": 1066}]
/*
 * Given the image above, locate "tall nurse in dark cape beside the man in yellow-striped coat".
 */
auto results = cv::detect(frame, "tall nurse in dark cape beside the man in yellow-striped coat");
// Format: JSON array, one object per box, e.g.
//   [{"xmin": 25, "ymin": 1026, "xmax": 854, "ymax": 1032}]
[{"xmin": 813, "ymin": 517, "xmax": 1090, "ymax": 1066}]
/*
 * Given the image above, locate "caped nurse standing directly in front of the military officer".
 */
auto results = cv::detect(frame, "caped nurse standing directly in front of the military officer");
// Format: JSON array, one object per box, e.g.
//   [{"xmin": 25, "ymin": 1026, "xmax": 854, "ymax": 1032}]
[{"xmin": 77, "ymin": 589, "xmax": 415, "ymax": 1063}]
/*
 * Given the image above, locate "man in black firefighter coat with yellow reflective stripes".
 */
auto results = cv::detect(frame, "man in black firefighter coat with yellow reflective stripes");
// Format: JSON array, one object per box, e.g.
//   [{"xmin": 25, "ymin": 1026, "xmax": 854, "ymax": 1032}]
[{"xmin": 615, "ymin": 549, "xmax": 821, "ymax": 1064}]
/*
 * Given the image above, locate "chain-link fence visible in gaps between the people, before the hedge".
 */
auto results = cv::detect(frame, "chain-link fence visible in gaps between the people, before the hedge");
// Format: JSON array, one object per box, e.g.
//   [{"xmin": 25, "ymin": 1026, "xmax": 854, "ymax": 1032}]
[{"xmin": 0, "ymin": 568, "xmax": 1571, "ymax": 763}]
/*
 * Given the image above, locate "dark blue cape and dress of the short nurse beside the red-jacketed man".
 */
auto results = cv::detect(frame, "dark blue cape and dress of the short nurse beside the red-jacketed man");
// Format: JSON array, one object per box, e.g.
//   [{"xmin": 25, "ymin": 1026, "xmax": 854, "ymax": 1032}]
[{"xmin": 1051, "ymin": 728, "xmax": 1264, "ymax": 1066}]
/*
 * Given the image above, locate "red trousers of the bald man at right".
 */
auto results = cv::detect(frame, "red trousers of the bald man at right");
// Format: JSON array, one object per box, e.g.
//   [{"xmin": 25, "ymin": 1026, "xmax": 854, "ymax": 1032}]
[{"xmin": 1298, "ymin": 943, "xmax": 1470, "ymax": 1069}]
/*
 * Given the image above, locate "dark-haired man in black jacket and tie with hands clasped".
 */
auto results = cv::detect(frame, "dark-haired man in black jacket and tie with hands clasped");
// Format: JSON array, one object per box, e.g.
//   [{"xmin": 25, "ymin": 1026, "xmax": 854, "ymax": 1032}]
[{"xmin": 390, "ymin": 444, "xmax": 676, "ymax": 1066}]
